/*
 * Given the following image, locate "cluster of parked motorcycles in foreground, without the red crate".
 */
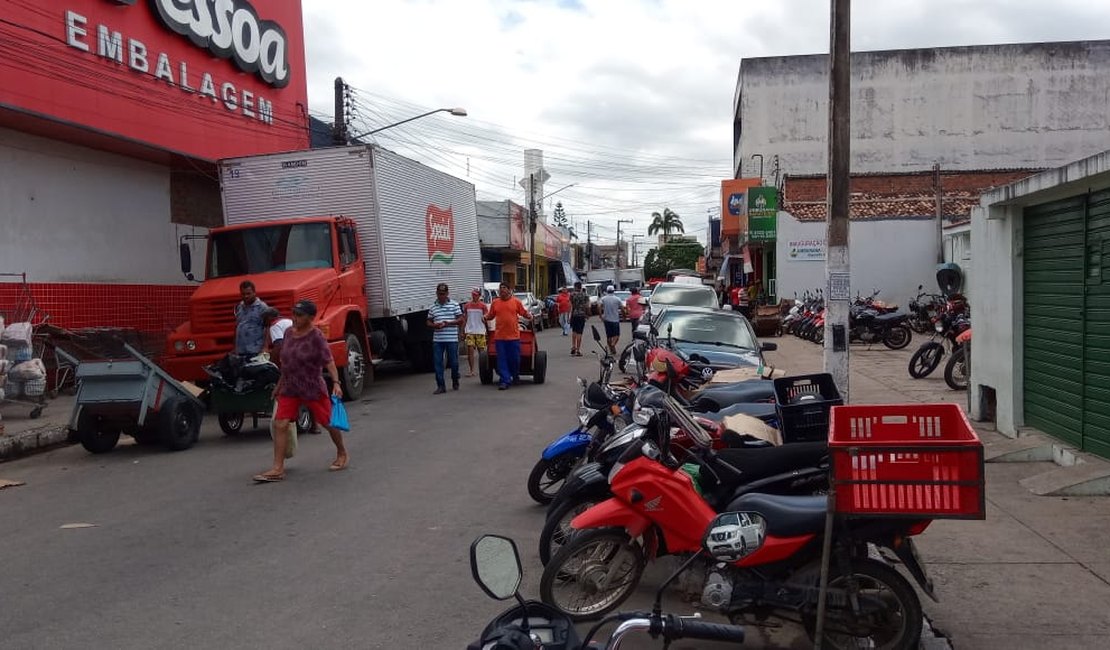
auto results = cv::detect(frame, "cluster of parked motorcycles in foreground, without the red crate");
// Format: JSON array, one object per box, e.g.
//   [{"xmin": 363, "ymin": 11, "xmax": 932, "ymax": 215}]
[{"xmin": 471, "ymin": 328, "xmax": 932, "ymax": 649}]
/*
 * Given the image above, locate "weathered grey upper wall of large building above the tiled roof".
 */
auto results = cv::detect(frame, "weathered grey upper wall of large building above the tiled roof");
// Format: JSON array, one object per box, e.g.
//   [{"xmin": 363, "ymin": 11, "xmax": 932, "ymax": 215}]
[{"xmin": 734, "ymin": 41, "xmax": 1110, "ymax": 177}]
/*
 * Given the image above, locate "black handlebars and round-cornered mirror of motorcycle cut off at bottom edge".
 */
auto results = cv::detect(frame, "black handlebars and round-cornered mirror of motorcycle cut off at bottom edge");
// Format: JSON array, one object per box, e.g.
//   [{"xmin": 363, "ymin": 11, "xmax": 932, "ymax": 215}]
[{"xmin": 467, "ymin": 535, "xmax": 744, "ymax": 650}]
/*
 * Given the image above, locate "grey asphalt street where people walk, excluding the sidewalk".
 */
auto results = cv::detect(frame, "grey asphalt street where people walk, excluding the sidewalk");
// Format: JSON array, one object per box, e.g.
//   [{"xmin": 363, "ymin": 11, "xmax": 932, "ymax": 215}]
[{"xmin": 0, "ymin": 318, "xmax": 805, "ymax": 649}]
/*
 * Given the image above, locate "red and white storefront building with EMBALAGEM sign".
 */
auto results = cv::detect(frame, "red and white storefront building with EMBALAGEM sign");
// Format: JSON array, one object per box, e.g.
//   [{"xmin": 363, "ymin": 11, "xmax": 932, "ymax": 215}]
[{"xmin": 0, "ymin": 0, "xmax": 309, "ymax": 334}]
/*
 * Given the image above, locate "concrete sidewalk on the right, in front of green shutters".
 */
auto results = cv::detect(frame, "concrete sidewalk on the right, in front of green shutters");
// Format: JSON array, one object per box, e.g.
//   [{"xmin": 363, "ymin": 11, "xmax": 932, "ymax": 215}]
[{"xmin": 766, "ymin": 336, "xmax": 1110, "ymax": 650}]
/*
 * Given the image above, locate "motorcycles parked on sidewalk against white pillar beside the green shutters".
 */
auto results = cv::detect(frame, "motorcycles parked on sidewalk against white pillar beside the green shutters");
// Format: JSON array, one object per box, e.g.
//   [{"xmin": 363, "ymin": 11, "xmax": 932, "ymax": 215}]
[{"xmin": 909, "ymin": 286, "xmax": 971, "ymax": 390}]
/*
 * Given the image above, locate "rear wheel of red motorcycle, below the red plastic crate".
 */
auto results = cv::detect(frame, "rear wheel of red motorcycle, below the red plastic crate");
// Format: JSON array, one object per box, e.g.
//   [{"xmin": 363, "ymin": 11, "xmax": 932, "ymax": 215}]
[{"xmin": 804, "ymin": 559, "xmax": 924, "ymax": 650}]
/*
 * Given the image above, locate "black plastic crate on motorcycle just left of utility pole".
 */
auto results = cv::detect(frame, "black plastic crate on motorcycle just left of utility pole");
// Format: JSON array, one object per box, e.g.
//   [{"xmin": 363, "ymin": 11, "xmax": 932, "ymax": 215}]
[{"xmin": 775, "ymin": 373, "xmax": 844, "ymax": 443}]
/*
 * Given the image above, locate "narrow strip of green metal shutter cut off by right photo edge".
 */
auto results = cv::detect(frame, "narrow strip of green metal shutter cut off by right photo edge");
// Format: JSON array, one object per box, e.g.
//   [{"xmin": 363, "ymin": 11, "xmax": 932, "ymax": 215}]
[{"xmin": 1083, "ymin": 192, "xmax": 1110, "ymax": 458}]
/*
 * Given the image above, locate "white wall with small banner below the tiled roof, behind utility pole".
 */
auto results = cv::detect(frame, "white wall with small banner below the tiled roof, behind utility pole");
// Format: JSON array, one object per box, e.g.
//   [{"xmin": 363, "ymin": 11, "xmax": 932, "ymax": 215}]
[{"xmin": 776, "ymin": 212, "xmax": 937, "ymax": 308}]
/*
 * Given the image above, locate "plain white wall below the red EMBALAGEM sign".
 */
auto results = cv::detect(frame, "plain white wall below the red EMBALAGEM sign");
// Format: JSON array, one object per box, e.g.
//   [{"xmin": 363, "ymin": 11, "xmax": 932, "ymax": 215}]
[{"xmin": 0, "ymin": 129, "xmax": 204, "ymax": 284}]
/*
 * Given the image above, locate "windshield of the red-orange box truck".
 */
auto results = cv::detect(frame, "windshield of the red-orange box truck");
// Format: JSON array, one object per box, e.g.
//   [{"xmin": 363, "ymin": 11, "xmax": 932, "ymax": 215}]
[{"xmin": 208, "ymin": 223, "xmax": 332, "ymax": 277}]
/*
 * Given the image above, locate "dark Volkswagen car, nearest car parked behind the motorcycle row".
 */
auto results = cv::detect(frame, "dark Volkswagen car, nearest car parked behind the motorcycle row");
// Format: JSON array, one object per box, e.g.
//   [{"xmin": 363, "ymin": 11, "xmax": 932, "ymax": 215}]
[{"xmin": 652, "ymin": 305, "xmax": 778, "ymax": 370}]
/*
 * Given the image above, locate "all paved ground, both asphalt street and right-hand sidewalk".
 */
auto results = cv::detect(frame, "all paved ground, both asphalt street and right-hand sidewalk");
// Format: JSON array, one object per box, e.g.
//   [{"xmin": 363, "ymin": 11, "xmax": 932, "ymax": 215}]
[{"xmin": 0, "ymin": 326, "xmax": 1110, "ymax": 649}]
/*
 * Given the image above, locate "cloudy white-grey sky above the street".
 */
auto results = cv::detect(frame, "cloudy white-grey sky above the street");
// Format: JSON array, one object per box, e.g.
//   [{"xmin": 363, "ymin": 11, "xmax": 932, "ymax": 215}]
[{"xmin": 303, "ymin": 0, "xmax": 1110, "ymax": 241}]
